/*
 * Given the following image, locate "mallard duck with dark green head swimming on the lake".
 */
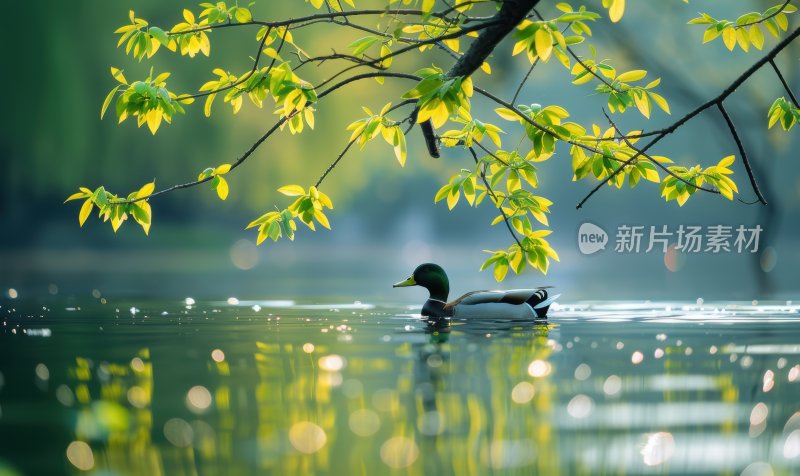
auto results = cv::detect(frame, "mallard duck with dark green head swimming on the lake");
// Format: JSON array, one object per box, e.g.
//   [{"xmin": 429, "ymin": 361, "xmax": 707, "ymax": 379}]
[{"xmin": 392, "ymin": 263, "xmax": 560, "ymax": 319}]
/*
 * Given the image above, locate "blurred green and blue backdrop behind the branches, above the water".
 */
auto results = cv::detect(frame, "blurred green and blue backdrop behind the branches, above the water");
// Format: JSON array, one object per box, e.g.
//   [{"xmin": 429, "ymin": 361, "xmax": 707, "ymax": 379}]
[{"xmin": 0, "ymin": 0, "xmax": 800, "ymax": 301}]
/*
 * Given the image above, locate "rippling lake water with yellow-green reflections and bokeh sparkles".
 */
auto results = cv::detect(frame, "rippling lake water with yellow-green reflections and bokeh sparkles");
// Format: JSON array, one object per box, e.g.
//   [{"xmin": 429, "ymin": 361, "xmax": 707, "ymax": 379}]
[{"xmin": 0, "ymin": 298, "xmax": 800, "ymax": 476}]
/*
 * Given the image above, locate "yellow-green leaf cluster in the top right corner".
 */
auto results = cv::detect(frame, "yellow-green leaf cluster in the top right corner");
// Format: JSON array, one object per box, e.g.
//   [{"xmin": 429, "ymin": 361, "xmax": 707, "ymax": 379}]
[{"xmin": 689, "ymin": 3, "xmax": 797, "ymax": 51}]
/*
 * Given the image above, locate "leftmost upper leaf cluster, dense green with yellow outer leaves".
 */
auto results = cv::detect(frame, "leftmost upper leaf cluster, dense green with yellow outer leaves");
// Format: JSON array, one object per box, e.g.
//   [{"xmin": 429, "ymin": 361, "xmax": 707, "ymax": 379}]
[{"xmin": 100, "ymin": 67, "xmax": 194, "ymax": 135}]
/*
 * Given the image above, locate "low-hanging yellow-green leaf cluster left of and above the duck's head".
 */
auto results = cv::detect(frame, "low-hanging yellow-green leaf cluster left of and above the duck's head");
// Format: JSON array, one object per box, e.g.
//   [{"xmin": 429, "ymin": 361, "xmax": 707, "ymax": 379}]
[{"xmin": 247, "ymin": 185, "xmax": 333, "ymax": 244}]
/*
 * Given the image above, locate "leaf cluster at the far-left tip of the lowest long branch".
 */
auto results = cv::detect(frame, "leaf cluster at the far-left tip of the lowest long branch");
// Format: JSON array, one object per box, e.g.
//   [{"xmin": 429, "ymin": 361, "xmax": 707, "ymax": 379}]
[{"xmin": 65, "ymin": 182, "xmax": 156, "ymax": 234}]
